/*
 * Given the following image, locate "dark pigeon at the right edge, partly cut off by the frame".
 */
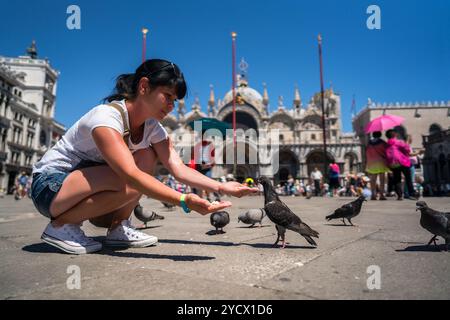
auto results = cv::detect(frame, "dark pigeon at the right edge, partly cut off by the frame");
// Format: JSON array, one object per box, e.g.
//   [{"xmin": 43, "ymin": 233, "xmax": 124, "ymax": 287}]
[{"xmin": 416, "ymin": 201, "xmax": 450, "ymax": 251}]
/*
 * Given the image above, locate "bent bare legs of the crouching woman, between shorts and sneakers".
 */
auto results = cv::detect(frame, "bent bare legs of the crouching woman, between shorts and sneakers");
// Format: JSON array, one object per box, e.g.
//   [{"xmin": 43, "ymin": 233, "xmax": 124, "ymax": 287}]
[{"xmin": 50, "ymin": 148, "xmax": 156, "ymax": 228}]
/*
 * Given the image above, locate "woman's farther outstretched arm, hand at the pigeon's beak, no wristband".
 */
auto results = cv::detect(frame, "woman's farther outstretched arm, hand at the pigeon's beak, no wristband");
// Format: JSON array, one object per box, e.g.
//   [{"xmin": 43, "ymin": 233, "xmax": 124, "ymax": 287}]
[{"xmin": 153, "ymin": 139, "xmax": 259, "ymax": 198}]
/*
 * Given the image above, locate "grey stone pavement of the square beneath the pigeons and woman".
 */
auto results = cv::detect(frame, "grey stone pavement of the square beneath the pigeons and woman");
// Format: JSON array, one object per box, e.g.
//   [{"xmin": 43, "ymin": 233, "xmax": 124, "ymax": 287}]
[{"xmin": 0, "ymin": 196, "xmax": 450, "ymax": 299}]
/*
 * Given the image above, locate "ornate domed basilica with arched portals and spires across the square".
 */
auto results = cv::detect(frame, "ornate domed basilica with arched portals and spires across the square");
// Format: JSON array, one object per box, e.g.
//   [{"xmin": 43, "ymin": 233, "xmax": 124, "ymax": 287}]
[{"xmin": 157, "ymin": 63, "xmax": 363, "ymax": 183}]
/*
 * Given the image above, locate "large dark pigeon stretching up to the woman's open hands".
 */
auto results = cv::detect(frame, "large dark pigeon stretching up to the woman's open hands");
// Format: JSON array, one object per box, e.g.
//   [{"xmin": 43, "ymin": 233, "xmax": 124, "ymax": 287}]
[{"xmin": 257, "ymin": 177, "xmax": 319, "ymax": 248}]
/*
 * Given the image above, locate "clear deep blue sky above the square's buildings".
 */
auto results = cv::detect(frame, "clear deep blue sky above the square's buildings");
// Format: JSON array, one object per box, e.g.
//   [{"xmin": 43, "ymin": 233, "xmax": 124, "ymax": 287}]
[{"xmin": 0, "ymin": 0, "xmax": 450, "ymax": 131}]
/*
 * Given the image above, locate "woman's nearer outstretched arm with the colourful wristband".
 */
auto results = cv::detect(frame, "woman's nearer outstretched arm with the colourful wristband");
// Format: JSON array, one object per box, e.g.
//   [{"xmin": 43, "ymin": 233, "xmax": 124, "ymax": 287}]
[{"xmin": 92, "ymin": 127, "xmax": 231, "ymax": 214}]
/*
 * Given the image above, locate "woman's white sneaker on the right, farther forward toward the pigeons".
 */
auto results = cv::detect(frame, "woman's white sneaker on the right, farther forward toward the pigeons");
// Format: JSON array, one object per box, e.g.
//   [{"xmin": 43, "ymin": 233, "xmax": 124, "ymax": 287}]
[{"xmin": 104, "ymin": 220, "xmax": 158, "ymax": 248}]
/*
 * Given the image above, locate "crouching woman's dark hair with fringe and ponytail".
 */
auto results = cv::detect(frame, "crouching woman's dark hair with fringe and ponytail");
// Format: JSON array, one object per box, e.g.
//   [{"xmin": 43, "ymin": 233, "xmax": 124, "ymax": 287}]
[{"xmin": 104, "ymin": 59, "xmax": 187, "ymax": 102}]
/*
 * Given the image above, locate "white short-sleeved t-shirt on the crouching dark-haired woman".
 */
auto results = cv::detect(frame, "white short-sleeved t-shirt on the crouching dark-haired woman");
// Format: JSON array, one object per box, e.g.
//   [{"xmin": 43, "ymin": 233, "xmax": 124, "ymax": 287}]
[{"xmin": 33, "ymin": 100, "xmax": 168, "ymax": 173}]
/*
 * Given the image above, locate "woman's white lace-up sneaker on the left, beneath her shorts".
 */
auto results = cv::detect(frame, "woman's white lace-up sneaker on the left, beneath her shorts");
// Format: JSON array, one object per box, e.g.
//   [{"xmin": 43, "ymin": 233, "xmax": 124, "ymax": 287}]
[{"xmin": 41, "ymin": 223, "xmax": 102, "ymax": 254}]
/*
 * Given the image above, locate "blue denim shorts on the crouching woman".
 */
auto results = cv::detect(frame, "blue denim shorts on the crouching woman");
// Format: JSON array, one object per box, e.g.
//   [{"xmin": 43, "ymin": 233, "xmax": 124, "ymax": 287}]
[{"xmin": 31, "ymin": 171, "xmax": 69, "ymax": 219}]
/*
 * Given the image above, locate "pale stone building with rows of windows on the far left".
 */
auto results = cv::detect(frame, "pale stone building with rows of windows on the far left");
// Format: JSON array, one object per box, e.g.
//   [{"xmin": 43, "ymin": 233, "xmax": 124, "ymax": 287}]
[{"xmin": 0, "ymin": 41, "xmax": 65, "ymax": 192}]
